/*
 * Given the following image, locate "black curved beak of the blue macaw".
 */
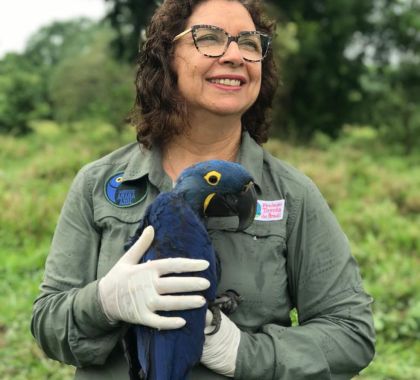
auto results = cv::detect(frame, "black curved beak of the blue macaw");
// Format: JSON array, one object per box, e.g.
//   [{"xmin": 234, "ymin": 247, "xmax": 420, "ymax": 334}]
[{"xmin": 204, "ymin": 181, "xmax": 257, "ymax": 231}]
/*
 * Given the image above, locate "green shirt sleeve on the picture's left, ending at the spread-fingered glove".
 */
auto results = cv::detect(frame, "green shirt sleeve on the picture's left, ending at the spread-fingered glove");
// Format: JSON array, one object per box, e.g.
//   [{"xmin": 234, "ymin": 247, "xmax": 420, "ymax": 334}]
[{"xmin": 31, "ymin": 169, "xmax": 125, "ymax": 367}]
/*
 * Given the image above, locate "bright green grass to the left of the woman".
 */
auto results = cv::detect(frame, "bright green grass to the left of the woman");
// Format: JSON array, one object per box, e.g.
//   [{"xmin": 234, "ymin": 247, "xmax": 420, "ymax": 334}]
[{"xmin": 0, "ymin": 122, "xmax": 133, "ymax": 380}]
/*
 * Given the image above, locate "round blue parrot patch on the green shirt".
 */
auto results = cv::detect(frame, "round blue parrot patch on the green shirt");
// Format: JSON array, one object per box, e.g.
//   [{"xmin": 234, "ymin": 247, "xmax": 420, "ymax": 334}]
[{"xmin": 104, "ymin": 173, "xmax": 147, "ymax": 207}]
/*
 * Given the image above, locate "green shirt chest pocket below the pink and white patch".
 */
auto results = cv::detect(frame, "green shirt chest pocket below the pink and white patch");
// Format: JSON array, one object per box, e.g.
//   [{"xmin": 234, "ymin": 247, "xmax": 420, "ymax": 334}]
[{"xmin": 208, "ymin": 218, "xmax": 290, "ymax": 331}]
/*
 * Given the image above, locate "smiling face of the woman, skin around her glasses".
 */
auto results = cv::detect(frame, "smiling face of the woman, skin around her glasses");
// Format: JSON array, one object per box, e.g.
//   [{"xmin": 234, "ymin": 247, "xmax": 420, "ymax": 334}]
[{"xmin": 173, "ymin": 0, "xmax": 261, "ymax": 117}]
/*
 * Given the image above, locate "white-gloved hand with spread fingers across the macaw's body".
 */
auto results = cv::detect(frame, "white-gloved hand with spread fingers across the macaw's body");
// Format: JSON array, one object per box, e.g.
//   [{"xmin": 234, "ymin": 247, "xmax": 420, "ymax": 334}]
[{"xmin": 99, "ymin": 226, "xmax": 210, "ymax": 330}]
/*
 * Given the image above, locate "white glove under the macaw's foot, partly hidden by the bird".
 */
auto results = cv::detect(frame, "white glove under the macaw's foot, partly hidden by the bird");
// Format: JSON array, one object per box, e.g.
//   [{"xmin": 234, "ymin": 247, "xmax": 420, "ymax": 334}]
[{"xmin": 201, "ymin": 310, "xmax": 241, "ymax": 377}]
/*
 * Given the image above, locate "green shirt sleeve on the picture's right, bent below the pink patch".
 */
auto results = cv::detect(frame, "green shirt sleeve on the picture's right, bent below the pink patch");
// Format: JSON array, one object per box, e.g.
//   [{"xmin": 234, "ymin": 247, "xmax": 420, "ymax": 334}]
[{"xmin": 235, "ymin": 182, "xmax": 375, "ymax": 380}]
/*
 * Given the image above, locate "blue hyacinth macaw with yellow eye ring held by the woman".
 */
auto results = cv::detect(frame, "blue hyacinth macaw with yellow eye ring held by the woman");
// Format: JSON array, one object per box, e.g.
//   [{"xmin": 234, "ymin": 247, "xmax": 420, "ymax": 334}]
[{"xmin": 125, "ymin": 160, "xmax": 257, "ymax": 380}]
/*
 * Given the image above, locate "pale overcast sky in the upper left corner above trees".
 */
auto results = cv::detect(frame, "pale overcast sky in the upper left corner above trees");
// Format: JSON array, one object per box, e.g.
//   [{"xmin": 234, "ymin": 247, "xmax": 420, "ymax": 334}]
[{"xmin": 0, "ymin": 0, "xmax": 106, "ymax": 58}]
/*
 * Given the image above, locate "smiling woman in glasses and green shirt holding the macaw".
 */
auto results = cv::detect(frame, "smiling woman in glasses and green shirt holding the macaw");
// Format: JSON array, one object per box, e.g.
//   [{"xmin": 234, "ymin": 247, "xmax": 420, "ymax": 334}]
[{"xmin": 32, "ymin": 0, "xmax": 374, "ymax": 380}]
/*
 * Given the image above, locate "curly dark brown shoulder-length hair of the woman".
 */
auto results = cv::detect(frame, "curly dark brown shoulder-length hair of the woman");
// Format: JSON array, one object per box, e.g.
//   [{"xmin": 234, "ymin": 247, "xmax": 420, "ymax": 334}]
[{"xmin": 129, "ymin": 0, "xmax": 278, "ymax": 148}]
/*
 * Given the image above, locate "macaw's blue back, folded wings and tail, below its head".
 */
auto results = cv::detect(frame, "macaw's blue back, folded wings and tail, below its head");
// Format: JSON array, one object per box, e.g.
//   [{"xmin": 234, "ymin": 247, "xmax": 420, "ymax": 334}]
[{"xmin": 136, "ymin": 193, "xmax": 217, "ymax": 380}]
